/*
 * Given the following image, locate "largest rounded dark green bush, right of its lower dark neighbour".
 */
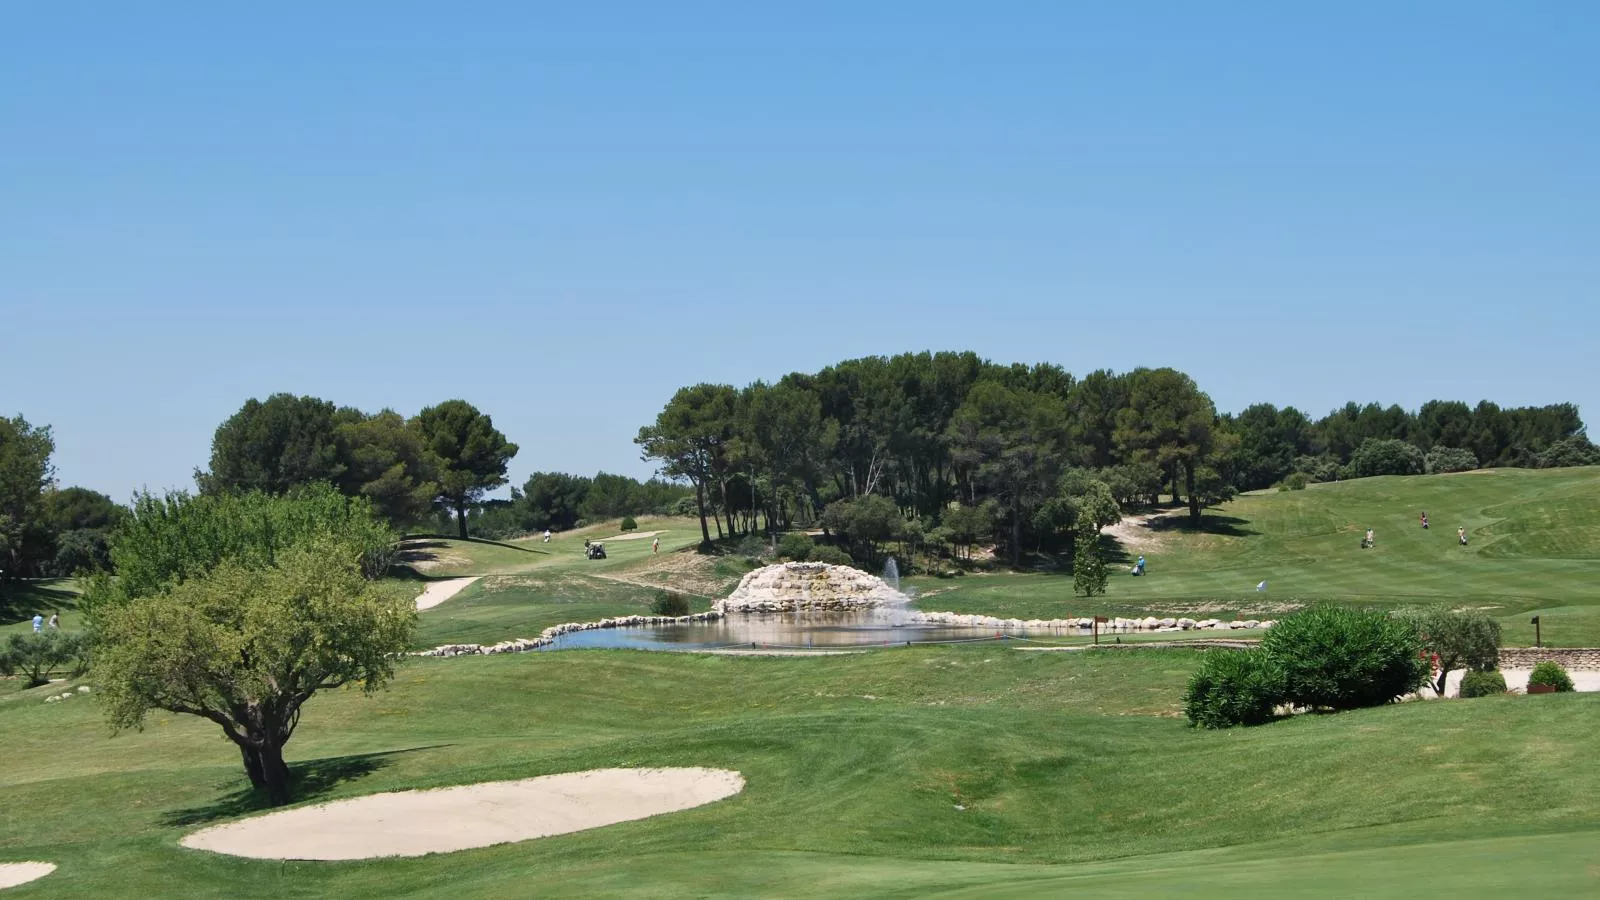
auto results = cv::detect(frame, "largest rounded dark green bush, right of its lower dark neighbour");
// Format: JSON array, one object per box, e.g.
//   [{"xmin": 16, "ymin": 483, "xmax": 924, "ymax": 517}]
[{"xmin": 1261, "ymin": 605, "xmax": 1429, "ymax": 709}]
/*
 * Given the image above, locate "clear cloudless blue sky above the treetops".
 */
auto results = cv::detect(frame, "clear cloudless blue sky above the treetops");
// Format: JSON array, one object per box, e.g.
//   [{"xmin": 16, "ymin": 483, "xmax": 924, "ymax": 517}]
[{"xmin": 0, "ymin": 0, "xmax": 1600, "ymax": 500}]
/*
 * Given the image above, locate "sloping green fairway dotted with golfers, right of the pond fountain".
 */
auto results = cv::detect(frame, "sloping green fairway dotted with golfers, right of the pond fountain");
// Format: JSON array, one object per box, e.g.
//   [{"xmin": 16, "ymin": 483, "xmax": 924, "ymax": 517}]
[{"xmin": 912, "ymin": 468, "xmax": 1600, "ymax": 647}]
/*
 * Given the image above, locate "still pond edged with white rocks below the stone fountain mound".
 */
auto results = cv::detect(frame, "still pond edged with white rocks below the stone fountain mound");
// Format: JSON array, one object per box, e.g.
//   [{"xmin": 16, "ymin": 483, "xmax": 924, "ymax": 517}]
[{"xmin": 542, "ymin": 610, "xmax": 1088, "ymax": 650}]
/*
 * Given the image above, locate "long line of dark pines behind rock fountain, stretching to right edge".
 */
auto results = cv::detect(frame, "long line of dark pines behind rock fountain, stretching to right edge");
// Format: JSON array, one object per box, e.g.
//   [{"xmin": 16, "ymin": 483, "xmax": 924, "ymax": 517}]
[{"xmin": 635, "ymin": 352, "xmax": 1600, "ymax": 560}]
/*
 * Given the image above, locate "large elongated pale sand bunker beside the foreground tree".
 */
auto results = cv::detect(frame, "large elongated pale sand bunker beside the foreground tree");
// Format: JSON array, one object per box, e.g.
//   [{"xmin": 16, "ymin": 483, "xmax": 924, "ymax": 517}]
[{"xmin": 182, "ymin": 769, "xmax": 744, "ymax": 860}]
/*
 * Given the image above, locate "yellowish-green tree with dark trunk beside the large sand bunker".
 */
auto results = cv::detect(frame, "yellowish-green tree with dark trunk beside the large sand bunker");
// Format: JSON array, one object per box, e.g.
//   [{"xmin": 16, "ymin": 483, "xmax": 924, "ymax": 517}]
[{"xmin": 93, "ymin": 536, "xmax": 416, "ymax": 806}]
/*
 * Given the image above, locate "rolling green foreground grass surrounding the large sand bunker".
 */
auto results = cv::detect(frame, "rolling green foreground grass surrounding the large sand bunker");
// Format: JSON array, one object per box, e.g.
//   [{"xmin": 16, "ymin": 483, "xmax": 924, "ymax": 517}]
[{"xmin": 0, "ymin": 645, "xmax": 1600, "ymax": 897}]
